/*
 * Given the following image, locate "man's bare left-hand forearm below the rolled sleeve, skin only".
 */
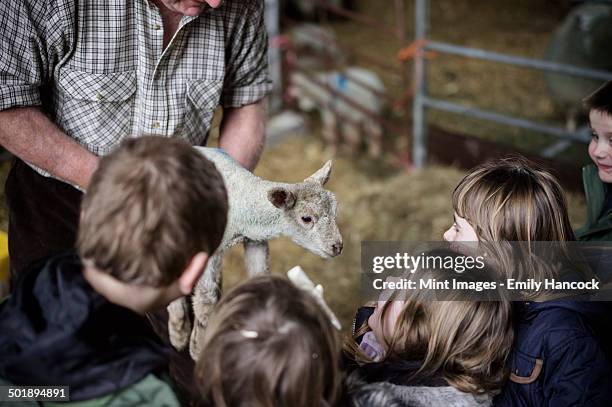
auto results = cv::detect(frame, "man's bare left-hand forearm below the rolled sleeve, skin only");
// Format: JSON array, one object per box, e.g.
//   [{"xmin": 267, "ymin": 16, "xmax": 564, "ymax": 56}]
[{"xmin": 0, "ymin": 107, "xmax": 98, "ymax": 189}]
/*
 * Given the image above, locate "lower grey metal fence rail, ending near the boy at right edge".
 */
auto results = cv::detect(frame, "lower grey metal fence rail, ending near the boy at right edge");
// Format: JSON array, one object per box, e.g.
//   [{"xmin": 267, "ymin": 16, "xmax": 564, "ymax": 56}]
[{"xmin": 423, "ymin": 96, "xmax": 589, "ymax": 142}]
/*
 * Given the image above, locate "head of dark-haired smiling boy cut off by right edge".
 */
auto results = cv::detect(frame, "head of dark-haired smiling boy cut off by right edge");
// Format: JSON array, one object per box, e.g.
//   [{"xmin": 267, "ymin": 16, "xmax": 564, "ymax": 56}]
[{"xmin": 584, "ymin": 81, "xmax": 612, "ymax": 183}]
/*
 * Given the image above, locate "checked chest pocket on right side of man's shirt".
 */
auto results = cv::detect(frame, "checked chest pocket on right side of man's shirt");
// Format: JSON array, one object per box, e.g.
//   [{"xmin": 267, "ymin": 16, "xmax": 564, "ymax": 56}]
[{"xmin": 181, "ymin": 79, "xmax": 223, "ymax": 145}]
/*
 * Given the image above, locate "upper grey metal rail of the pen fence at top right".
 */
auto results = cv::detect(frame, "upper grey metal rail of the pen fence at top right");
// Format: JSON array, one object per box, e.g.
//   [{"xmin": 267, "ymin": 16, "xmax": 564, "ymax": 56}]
[{"xmin": 424, "ymin": 41, "xmax": 612, "ymax": 81}]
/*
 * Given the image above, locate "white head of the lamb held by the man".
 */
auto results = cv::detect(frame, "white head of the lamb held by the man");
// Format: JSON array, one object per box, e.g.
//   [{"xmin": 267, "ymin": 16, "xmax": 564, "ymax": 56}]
[{"xmin": 268, "ymin": 161, "xmax": 342, "ymax": 258}]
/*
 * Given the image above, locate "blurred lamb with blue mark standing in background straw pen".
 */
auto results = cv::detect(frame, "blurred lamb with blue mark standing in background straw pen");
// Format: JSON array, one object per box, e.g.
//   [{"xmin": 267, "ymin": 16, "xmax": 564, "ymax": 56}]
[{"xmin": 289, "ymin": 67, "xmax": 385, "ymax": 157}]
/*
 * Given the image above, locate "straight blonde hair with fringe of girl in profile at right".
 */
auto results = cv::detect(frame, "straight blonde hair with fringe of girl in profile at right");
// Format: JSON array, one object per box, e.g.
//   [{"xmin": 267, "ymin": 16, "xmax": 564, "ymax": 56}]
[{"xmin": 453, "ymin": 157, "xmax": 596, "ymax": 301}]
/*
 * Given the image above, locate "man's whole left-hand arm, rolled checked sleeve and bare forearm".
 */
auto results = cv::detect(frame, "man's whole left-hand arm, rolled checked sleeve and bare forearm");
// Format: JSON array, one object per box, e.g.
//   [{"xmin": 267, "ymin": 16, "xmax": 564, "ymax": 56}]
[{"xmin": 0, "ymin": 0, "xmax": 97, "ymax": 188}]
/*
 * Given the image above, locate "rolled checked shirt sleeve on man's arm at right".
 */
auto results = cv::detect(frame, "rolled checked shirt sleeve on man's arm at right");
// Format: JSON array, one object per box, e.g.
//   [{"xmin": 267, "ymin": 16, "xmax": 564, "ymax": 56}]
[{"xmin": 221, "ymin": 0, "xmax": 272, "ymax": 107}]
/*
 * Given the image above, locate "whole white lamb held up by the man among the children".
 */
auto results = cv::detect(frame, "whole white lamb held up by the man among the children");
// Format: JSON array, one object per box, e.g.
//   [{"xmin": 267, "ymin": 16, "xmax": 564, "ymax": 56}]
[{"xmin": 168, "ymin": 147, "xmax": 342, "ymax": 360}]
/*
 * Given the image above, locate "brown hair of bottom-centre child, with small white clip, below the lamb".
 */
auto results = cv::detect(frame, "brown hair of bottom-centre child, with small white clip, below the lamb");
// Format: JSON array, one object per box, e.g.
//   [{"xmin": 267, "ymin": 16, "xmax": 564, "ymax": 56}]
[{"xmin": 196, "ymin": 275, "xmax": 341, "ymax": 407}]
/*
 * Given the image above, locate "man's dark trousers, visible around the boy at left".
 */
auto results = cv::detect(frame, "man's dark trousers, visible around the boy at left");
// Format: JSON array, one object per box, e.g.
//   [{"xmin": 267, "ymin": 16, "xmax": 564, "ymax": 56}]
[{"xmin": 5, "ymin": 159, "xmax": 199, "ymax": 406}]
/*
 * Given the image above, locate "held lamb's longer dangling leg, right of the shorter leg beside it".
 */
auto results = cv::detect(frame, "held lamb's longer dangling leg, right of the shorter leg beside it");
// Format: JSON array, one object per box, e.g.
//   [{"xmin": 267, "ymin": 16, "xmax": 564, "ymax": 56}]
[{"xmin": 189, "ymin": 252, "xmax": 223, "ymax": 360}]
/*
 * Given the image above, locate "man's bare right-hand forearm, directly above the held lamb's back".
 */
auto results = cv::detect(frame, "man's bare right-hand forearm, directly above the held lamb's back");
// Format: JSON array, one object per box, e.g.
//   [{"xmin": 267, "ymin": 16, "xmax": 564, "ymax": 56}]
[{"xmin": 219, "ymin": 99, "xmax": 266, "ymax": 170}]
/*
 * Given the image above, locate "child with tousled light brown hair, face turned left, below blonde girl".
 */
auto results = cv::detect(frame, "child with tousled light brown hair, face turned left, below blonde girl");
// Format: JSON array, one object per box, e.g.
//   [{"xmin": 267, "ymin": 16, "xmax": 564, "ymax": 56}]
[{"xmin": 345, "ymin": 255, "xmax": 512, "ymax": 407}]
